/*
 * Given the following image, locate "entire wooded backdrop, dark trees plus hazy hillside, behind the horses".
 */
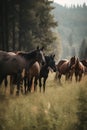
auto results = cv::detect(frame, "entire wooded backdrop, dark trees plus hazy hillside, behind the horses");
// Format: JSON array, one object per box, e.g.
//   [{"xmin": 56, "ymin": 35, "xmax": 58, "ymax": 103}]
[{"xmin": 0, "ymin": 0, "xmax": 87, "ymax": 60}]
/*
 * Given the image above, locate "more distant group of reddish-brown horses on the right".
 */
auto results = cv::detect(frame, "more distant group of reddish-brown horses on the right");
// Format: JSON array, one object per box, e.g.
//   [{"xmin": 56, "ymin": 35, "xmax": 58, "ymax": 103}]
[{"xmin": 56, "ymin": 56, "xmax": 87, "ymax": 82}]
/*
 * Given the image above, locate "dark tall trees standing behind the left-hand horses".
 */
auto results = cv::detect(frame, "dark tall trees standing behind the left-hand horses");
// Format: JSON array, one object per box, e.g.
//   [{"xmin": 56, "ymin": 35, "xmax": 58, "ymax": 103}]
[{"xmin": 0, "ymin": 0, "xmax": 57, "ymax": 51}]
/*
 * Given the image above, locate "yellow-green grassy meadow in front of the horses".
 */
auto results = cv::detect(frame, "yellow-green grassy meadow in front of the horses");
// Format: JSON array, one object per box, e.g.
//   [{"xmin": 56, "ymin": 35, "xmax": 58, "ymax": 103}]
[{"xmin": 0, "ymin": 73, "xmax": 87, "ymax": 130}]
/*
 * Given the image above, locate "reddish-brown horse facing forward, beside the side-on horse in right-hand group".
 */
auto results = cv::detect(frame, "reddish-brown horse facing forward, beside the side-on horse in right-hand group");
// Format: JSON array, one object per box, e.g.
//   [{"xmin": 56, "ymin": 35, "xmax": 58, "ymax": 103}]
[{"xmin": 74, "ymin": 58, "xmax": 86, "ymax": 82}]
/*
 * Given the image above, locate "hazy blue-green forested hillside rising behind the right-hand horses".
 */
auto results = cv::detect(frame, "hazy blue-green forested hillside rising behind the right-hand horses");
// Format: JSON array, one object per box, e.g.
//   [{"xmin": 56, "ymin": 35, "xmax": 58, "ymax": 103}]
[{"xmin": 53, "ymin": 3, "xmax": 87, "ymax": 58}]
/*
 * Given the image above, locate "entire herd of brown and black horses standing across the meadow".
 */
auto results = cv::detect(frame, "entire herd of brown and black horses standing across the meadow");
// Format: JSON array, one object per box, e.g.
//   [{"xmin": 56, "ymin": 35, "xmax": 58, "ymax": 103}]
[{"xmin": 0, "ymin": 47, "xmax": 87, "ymax": 95}]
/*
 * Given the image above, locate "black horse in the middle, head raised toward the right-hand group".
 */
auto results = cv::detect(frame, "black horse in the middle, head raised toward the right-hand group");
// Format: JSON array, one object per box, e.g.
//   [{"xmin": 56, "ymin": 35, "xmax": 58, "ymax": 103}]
[{"xmin": 34, "ymin": 55, "xmax": 56, "ymax": 92}]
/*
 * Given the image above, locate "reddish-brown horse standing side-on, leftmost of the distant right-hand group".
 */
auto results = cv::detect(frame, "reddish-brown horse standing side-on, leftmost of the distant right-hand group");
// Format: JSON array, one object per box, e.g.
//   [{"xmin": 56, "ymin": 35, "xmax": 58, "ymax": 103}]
[{"xmin": 56, "ymin": 56, "xmax": 76, "ymax": 82}]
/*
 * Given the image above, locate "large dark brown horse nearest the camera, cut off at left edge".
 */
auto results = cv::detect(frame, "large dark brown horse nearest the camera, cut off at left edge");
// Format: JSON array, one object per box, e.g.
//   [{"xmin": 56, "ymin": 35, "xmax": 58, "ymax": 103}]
[{"xmin": 0, "ymin": 47, "xmax": 45, "ymax": 94}]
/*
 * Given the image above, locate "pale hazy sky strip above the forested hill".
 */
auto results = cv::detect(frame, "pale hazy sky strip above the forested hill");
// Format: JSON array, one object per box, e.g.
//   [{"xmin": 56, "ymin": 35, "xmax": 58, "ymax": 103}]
[{"xmin": 54, "ymin": 0, "xmax": 87, "ymax": 6}]
